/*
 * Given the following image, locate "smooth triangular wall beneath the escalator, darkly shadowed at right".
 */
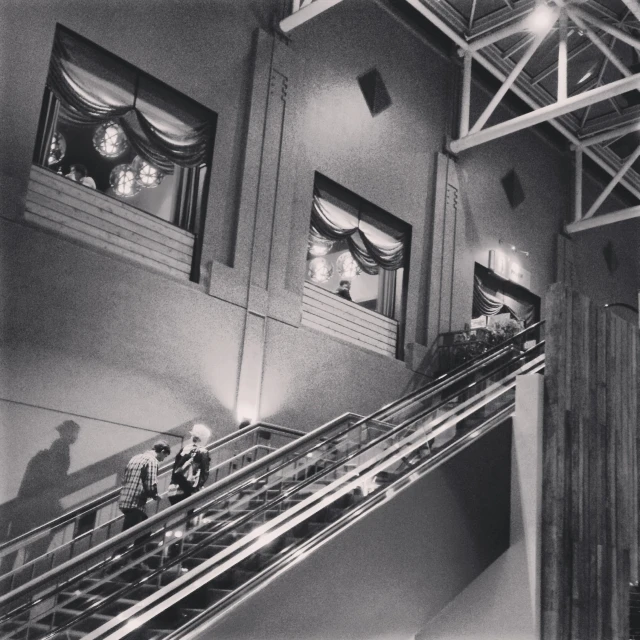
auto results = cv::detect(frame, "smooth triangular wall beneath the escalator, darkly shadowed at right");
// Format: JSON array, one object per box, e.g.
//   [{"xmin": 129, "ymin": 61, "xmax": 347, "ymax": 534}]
[{"xmin": 205, "ymin": 420, "xmax": 511, "ymax": 640}]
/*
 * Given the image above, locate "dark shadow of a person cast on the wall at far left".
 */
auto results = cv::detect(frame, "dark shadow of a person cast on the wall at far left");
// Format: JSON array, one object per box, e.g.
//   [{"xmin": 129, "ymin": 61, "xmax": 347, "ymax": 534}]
[{"xmin": 3, "ymin": 420, "xmax": 80, "ymax": 571}]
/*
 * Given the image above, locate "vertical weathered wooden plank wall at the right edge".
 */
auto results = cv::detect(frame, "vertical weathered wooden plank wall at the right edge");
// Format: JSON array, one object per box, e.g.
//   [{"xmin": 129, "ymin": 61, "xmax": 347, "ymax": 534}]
[{"xmin": 541, "ymin": 283, "xmax": 639, "ymax": 640}]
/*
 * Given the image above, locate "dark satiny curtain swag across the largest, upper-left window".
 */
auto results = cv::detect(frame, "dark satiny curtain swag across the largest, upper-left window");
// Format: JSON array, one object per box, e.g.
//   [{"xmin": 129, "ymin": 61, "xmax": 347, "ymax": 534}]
[{"xmin": 47, "ymin": 30, "xmax": 211, "ymax": 173}]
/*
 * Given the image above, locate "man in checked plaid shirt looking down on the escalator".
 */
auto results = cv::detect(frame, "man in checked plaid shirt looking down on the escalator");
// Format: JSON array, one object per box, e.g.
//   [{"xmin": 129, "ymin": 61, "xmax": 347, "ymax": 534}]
[{"xmin": 118, "ymin": 440, "xmax": 171, "ymax": 531}]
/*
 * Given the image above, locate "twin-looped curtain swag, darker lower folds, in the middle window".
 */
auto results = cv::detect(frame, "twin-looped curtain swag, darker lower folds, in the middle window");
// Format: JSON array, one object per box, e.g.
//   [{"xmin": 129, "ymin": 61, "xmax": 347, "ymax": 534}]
[{"xmin": 311, "ymin": 194, "xmax": 404, "ymax": 275}]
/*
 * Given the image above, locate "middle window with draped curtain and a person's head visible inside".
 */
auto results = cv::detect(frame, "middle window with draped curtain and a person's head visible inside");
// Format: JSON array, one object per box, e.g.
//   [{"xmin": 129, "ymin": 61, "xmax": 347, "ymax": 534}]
[{"xmin": 306, "ymin": 175, "xmax": 410, "ymax": 320}]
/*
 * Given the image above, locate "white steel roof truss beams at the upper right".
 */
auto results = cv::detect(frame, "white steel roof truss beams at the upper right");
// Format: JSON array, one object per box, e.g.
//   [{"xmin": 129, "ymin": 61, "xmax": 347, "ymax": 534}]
[{"xmin": 280, "ymin": 0, "xmax": 640, "ymax": 232}]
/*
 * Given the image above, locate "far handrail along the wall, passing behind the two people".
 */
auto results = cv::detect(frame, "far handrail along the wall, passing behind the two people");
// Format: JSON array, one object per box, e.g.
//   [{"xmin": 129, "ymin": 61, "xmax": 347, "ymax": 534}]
[{"xmin": 0, "ymin": 422, "xmax": 304, "ymax": 556}]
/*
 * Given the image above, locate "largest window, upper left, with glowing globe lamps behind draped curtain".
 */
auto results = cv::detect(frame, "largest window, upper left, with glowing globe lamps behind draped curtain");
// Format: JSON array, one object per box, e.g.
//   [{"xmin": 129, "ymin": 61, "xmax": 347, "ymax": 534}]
[{"xmin": 34, "ymin": 27, "xmax": 216, "ymax": 235}]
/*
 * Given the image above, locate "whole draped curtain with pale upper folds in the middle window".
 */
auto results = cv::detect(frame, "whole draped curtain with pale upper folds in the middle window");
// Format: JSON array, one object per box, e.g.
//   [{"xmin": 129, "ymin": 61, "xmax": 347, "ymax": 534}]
[{"xmin": 311, "ymin": 193, "xmax": 404, "ymax": 275}]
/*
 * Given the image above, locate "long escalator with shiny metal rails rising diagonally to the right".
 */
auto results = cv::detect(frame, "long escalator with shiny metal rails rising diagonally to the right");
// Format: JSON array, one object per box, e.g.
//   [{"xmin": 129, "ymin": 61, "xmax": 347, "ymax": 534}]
[{"xmin": 0, "ymin": 325, "xmax": 544, "ymax": 640}]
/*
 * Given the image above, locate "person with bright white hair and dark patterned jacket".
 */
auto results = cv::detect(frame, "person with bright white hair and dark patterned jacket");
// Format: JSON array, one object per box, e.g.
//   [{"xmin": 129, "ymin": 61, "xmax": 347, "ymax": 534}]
[{"xmin": 167, "ymin": 424, "xmax": 211, "ymax": 504}]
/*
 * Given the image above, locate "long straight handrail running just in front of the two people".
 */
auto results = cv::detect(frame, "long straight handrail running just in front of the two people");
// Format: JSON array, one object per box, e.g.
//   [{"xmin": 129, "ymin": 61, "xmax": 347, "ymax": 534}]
[{"xmin": 0, "ymin": 343, "xmax": 543, "ymax": 606}]
